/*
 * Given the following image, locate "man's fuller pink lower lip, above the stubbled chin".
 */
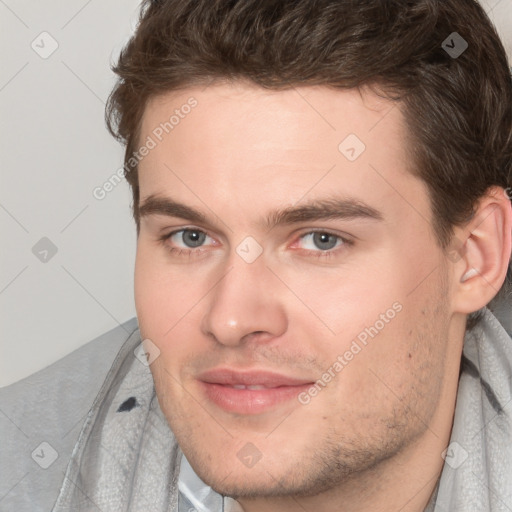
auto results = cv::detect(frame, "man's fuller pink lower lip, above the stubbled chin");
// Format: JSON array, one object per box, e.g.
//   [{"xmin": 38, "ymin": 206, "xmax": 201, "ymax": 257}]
[{"xmin": 199, "ymin": 381, "xmax": 313, "ymax": 414}]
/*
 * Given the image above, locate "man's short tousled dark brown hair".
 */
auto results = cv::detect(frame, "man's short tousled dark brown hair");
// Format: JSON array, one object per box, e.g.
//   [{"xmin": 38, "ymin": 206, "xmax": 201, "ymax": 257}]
[{"xmin": 106, "ymin": 0, "xmax": 512, "ymax": 324}]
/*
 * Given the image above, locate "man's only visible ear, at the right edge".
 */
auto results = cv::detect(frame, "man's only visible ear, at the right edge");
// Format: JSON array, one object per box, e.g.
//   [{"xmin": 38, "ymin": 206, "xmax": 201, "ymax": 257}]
[{"xmin": 448, "ymin": 187, "xmax": 512, "ymax": 314}]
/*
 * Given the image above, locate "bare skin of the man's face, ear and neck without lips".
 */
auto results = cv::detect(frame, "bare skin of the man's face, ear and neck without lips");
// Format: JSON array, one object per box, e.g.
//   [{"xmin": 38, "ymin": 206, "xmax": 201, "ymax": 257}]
[{"xmin": 135, "ymin": 82, "xmax": 512, "ymax": 512}]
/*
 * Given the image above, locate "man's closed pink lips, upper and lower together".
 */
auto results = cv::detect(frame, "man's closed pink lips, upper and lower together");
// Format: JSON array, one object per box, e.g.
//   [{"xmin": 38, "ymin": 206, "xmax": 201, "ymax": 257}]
[{"xmin": 197, "ymin": 368, "xmax": 314, "ymax": 415}]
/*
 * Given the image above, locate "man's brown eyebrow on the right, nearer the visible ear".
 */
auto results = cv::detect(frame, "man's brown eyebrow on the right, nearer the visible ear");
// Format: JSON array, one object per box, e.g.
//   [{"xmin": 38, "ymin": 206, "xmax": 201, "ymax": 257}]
[{"xmin": 266, "ymin": 198, "xmax": 384, "ymax": 229}]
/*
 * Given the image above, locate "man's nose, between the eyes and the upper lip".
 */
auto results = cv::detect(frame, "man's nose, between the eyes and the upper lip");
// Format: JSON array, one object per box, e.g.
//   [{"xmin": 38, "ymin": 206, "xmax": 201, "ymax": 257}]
[{"xmin": 201, "ymin": 254, "xmax": 287, "ymax": 346}]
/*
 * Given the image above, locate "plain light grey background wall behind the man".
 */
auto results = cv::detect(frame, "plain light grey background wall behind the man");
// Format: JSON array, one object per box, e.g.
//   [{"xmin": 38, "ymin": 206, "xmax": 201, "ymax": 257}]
[{"xmin": 0, "ymin": 0, "xmax": 512, "ymax": 386}]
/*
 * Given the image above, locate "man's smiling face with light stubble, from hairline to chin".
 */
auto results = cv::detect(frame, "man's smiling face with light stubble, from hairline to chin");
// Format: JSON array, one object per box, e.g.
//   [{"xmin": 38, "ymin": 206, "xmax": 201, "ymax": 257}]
[{"xmin": 135, "ymin": 84, "xmax": 453, "ymax": 496}]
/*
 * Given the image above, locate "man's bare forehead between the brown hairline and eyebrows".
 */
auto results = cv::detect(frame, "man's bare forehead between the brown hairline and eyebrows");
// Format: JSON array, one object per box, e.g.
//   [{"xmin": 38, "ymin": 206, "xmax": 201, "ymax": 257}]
[{"xmin": 139, "ymin": 83, "xmax": 429, "ymax": 228}]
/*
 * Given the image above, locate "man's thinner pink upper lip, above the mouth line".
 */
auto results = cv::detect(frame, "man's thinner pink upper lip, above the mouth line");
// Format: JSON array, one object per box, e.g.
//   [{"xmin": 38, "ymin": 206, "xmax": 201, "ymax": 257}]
[{"xmin": 197, "ymin": 368, "xmax": 313, "ymax": 388}]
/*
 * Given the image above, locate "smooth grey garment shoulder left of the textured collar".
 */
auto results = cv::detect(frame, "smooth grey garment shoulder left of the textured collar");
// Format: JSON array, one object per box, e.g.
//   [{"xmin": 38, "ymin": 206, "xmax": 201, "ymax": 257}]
[{"xmin": 0, "ymin": 318, "xmax": 138, "ymax": 511}]
